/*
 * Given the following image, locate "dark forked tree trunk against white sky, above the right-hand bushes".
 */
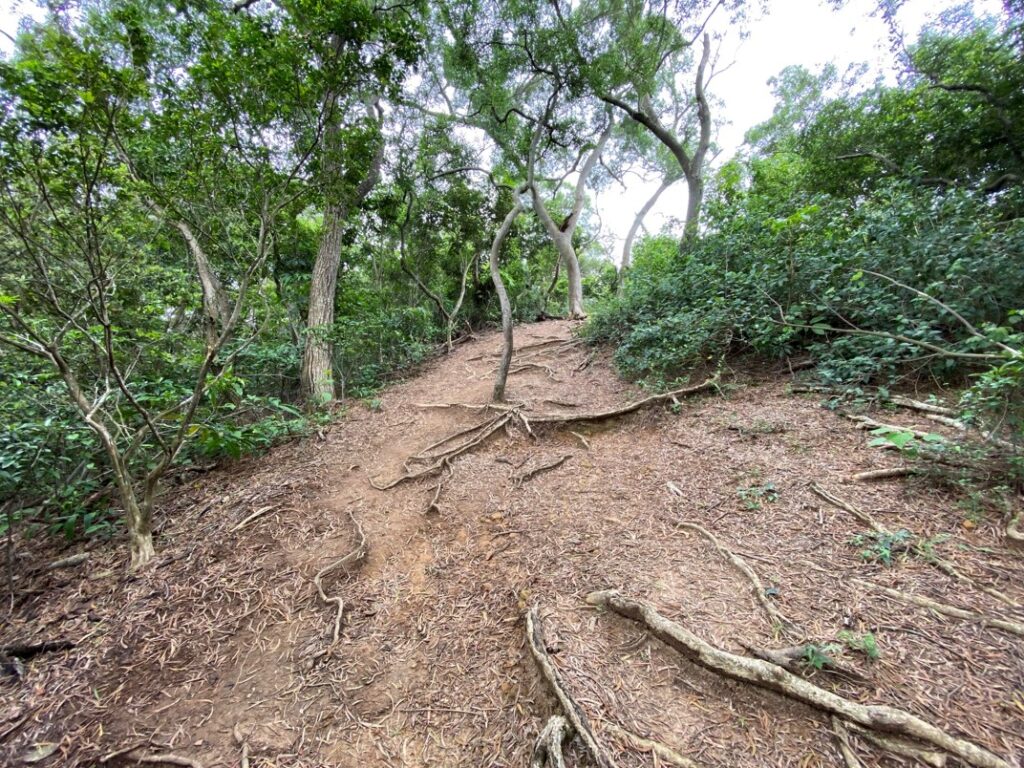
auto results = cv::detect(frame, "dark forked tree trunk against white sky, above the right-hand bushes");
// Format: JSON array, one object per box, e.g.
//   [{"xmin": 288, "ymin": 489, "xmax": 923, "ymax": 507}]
[{"xmin": 600, "ymin": 33, "xmax": 712, "ymax": 250}]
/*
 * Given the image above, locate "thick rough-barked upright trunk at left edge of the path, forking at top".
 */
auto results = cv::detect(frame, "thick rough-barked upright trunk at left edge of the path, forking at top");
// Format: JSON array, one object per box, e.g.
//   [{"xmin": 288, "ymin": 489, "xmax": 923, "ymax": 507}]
[{"xmin": 300, "ymin": 104, "xmax": 384, "ymax": 406}]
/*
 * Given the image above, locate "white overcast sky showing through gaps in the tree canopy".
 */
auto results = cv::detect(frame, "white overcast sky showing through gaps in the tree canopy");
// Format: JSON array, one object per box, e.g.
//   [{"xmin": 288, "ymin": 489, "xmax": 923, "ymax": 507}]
[{"xmin": 0, "ymin": 0, "xmax": 1000, "ymax": 262}]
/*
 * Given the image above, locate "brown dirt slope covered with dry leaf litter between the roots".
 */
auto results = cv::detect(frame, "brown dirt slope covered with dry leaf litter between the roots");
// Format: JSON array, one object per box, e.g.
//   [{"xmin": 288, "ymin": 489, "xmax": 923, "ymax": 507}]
[{"xmin": 0, "ymin": 322, "xmax": 1024, "ymax": 768}]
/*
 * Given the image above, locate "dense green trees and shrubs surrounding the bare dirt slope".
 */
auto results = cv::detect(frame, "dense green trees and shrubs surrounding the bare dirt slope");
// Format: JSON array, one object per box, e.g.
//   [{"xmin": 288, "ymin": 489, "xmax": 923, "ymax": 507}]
[{"xmin": 0, "ymin": 0, "xmax": 1024, "ymax": 564}]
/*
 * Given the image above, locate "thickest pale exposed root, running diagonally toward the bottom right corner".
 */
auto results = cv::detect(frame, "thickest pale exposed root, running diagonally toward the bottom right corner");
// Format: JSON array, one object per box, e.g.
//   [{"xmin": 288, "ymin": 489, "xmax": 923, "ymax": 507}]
[{"xmin": 587, "ymin": 590, "xmax": 1011, "ymax": 768}]
